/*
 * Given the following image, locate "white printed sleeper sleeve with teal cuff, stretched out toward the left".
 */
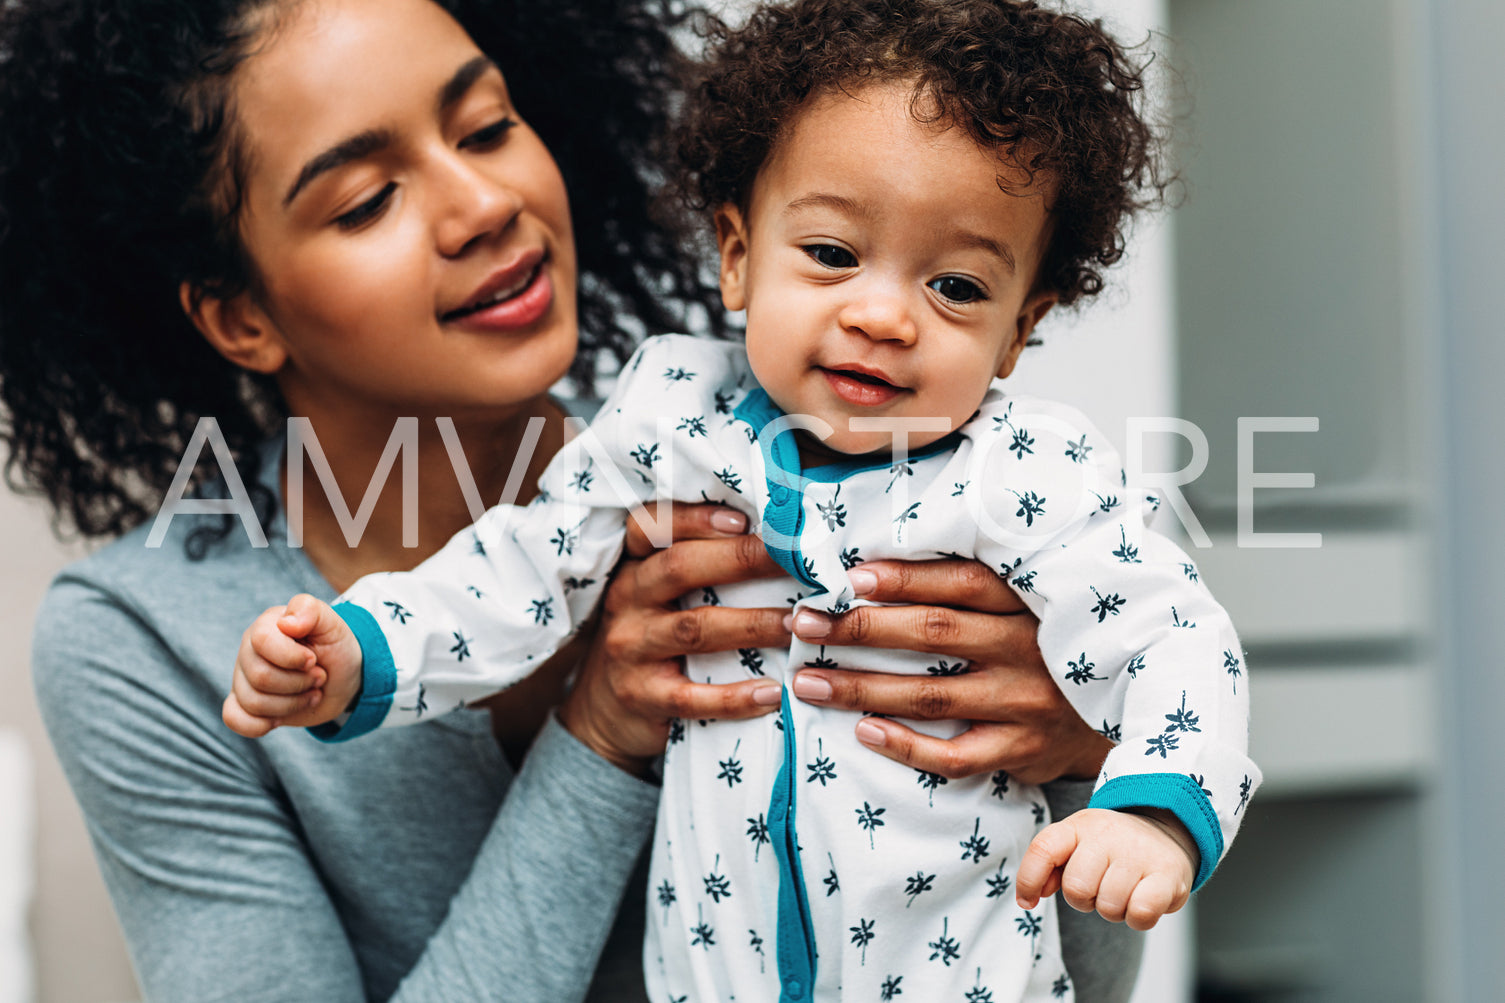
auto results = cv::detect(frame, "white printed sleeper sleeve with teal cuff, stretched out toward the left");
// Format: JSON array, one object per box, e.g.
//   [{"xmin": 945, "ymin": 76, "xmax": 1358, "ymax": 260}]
[{"xmin": 322, "ymin": 347, "xmax": 677, "ymax": 741}]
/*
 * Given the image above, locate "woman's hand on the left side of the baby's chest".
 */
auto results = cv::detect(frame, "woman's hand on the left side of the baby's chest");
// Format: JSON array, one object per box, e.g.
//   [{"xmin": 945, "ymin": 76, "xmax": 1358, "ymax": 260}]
[{"xmin": 560, "ymin": 505, "xmax": 789, "ymax": 776}]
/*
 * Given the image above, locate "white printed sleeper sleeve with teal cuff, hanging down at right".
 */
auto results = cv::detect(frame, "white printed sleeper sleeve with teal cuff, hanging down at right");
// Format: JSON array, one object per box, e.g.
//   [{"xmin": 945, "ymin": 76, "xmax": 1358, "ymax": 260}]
[{"xmin": 975, "ymin": 399, "xmax": 1260, "ymax": 887}]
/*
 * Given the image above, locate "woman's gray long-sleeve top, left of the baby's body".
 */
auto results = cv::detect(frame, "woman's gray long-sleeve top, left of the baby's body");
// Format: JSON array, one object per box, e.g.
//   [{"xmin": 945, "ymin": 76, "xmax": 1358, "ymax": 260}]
[{"xmin": 33, "ymin": 448, "xmax": 658, "ymax": 1003}]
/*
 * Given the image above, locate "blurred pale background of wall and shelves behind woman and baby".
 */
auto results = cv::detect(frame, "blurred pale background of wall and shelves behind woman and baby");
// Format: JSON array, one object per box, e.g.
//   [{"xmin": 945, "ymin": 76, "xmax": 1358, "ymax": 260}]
[{"xmin": 0, "ymin": 0, "xmax": 1505, "ymax": 1003}]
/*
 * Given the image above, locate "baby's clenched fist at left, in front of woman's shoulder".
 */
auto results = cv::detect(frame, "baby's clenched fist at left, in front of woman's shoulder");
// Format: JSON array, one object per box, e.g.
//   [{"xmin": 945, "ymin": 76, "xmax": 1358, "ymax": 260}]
[{"xmin": 223, "ymin": 595, "xmax": 361, "ymax": 738}]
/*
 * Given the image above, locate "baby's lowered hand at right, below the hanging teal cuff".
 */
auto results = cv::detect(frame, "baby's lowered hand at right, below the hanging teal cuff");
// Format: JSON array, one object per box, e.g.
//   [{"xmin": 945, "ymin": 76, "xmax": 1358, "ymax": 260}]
[{"xmin": 1014, "ymin": 809, "xmax": 1198, "ymax": 929}]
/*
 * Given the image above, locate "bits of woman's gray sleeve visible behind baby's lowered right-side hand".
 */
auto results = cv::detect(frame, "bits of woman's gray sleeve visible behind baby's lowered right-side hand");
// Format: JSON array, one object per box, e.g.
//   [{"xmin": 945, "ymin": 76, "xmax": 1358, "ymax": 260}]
[{"xmin": 1044, "ymin": 780, "xmax": 1144, "ymax": 1003}]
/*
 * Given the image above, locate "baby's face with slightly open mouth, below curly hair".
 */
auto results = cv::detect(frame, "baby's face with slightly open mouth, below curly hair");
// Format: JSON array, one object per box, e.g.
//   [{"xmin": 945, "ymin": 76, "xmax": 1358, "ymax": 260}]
[{"xmin": 716, "ymin": 81, "xmax": 1055, "ymax": 453}]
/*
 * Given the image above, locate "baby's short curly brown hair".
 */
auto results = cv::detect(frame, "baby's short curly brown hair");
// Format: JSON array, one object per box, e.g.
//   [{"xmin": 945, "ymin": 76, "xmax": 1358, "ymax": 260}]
[{"xmin": 674, "ymin": 0, "xmax": 1174, "ymax": 304}]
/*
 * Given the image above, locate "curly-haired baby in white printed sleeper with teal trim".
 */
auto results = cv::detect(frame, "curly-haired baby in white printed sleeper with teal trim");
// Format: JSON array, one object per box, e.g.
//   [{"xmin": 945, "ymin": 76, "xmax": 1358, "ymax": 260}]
[{"xmin": 227, "ymin": 0, "xmax": 1260, "ymax": 1003}]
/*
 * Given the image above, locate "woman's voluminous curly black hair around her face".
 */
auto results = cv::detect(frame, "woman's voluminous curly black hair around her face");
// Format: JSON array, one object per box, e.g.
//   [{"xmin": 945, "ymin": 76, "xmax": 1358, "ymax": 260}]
[{"xmin": 0, "ymin": 0, "xmax": 719, "ymax": 551}]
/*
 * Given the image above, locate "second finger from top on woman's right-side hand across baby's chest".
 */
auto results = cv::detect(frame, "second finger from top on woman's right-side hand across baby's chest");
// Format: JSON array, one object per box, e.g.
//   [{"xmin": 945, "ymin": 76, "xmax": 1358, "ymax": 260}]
[{"xmin": 793, "ymin": 605, "xmax": 1040, "ymax": 661}]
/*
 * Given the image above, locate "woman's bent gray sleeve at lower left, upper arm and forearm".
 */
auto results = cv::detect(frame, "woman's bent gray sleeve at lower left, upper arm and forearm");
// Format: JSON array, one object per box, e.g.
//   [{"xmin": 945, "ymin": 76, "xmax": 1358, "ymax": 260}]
[{"xmin": 33, "ymin": 580, "xmax": 658, "ymax": 1003}]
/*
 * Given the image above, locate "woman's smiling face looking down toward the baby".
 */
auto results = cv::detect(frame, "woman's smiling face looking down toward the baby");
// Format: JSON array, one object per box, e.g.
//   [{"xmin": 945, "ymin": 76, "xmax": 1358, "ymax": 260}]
[{"xmin": 219, "ymin": 0, "xmax": 576, "ymax": 419}]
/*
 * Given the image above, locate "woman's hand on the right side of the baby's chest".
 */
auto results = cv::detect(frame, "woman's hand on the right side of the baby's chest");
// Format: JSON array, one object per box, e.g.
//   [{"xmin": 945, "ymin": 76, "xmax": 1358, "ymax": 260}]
[{"xmin": 793, "ymin": 560, "xmax": 1112, "ymax": 783}]
